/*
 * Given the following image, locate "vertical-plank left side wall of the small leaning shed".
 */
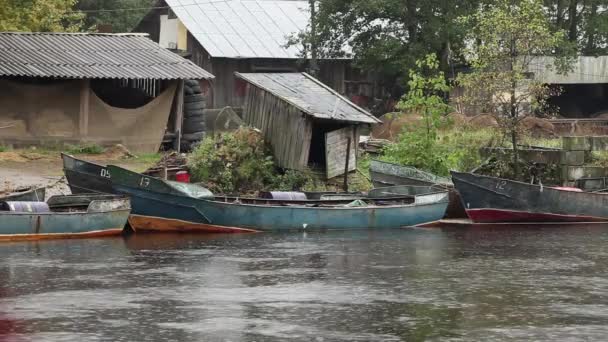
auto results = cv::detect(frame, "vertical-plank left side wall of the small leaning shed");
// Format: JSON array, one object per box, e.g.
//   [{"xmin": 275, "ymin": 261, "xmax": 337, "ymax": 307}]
[{"xmin": 243, "ymin": 84, "xmax": 312, "ymax": 170}]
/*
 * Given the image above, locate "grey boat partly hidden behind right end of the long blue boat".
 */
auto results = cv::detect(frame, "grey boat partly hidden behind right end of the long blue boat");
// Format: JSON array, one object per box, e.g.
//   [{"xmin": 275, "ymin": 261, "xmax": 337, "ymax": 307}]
[{"xmin": 370, "ymin": 160, "xmax": 467, "ymax": 218}]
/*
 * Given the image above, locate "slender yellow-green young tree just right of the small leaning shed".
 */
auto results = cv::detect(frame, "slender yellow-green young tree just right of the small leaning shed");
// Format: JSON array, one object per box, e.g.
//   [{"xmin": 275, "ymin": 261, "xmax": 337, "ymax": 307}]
[{"xmin": 384, "ymin": 54, "xmax": 451, "ymax": 175}]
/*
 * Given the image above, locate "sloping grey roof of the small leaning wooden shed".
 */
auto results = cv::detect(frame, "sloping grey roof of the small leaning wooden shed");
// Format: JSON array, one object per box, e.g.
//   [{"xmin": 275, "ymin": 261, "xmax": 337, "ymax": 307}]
[{"xmin": 236, "ymin": 73, "xmax": 380, "ymax": 123}]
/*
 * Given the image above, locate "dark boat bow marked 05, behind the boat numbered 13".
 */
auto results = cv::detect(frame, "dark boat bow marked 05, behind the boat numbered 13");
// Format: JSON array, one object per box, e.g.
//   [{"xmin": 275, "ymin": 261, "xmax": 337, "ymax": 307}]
[{"xmin": 61, "ymin": 153, "xmax": 113, "ymax": 194}]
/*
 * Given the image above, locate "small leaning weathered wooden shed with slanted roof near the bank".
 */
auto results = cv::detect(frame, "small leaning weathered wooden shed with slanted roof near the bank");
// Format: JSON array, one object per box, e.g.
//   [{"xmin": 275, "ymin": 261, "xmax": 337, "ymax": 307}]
[{"xmin": 235, "ymin": 73, "xmax": 380, "ymax": 178}]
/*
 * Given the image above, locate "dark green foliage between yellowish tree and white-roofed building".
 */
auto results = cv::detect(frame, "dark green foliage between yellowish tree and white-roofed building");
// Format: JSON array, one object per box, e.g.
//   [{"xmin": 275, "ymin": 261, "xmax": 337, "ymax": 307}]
[{"xmin": 76, "ymin": 0, "xmax": 157, "ymax": 32}]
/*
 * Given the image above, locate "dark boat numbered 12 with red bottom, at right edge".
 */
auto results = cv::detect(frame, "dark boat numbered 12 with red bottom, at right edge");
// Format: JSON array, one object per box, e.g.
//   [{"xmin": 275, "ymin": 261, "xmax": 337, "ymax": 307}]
[{"xmin": 452, "ymin": 172, "xmax": 608, "ymax": 223}]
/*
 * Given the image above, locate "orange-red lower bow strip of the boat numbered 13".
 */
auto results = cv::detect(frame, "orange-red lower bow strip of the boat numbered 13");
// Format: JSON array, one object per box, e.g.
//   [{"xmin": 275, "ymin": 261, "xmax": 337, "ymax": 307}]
[{"xmin": 129, "ymin": 215, "xmax": 259, "ymax": 233}]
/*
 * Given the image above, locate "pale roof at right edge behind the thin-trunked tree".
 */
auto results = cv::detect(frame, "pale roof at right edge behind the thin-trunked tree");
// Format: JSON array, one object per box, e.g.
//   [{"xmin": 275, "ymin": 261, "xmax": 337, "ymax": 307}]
[{"xmin": 529, "ymin": 56, "xmax": 608, "ymax": 84}]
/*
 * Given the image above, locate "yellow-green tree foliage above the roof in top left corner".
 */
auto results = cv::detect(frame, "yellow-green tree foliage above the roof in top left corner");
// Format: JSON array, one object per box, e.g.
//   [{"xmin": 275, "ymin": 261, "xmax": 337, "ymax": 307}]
[{"xmin": 0, "ymin": 0, "xmax": 82, "ymax": 32}]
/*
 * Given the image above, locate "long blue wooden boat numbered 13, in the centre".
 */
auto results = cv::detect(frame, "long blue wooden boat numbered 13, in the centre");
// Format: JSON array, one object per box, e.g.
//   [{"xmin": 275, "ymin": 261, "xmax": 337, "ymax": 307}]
[{"xmin": 108, "ymin": 165, "xmax": 448, "ymax": 231}]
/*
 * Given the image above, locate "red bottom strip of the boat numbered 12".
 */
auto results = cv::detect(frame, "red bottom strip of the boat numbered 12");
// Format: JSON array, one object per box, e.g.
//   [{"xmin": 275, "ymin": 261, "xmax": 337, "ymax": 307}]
[{"xmin": 466, "ymin": 208, "xmax": 608, "ymax": 223}]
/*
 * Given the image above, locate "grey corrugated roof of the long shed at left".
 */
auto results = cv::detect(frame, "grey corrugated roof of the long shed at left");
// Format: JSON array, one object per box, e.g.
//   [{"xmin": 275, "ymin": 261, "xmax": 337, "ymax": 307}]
[{"xmin": 0, "ymin": 32, "xmax": 213, "ymax": 79}]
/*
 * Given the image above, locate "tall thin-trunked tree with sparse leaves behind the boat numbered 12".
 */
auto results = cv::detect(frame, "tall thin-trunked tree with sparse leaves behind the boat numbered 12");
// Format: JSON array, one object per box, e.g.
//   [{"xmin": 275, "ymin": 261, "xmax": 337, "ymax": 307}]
[{"xmin": 458, "ymin": 0, "xmax": 571, "ymax": 177}]
